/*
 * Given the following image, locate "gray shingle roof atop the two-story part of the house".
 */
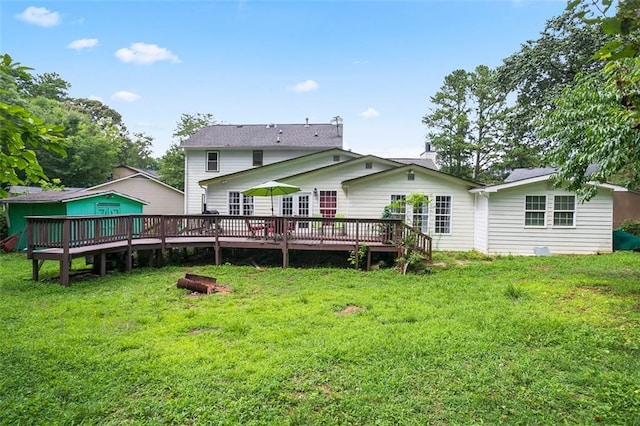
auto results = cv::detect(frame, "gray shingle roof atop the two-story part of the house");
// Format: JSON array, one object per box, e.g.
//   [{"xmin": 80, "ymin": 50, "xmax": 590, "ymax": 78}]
[{"xmin": 181, "ymin": 124, "xmax": 343, "ymax": 149}]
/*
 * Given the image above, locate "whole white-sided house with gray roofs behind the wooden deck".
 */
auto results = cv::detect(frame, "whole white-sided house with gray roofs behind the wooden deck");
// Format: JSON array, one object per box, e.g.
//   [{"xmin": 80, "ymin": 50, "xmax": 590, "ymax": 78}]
[{"xmin": 184, "ymin": 124, "xmax": 632, "ymax": 255}]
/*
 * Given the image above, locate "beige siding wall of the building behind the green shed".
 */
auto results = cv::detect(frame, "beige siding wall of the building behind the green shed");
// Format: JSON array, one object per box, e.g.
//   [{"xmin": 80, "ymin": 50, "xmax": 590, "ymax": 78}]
[{"xmin": 89, "ymin": 176, "xmax": 184, "ymax": 214}]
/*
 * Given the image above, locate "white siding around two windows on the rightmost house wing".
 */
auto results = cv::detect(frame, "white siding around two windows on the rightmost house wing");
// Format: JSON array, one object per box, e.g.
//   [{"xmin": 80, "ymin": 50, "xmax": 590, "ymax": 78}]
[{"xmin": 489, "ymin": 182, "xmax": 613, "ymax": 255}]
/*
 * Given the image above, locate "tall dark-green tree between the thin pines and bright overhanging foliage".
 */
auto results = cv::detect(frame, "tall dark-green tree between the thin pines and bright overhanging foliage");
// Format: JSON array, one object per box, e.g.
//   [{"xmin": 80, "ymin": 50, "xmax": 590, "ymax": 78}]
[{"xmin": 498, "ymin": 7, "xmax": 610, "ymax": 169}]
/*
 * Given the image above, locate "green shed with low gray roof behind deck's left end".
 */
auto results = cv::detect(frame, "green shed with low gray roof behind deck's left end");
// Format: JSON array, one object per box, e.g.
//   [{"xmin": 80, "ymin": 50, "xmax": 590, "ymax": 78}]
[{"xmin": 0, "ymin": 191, "xmax": 147, "ymax": 250}]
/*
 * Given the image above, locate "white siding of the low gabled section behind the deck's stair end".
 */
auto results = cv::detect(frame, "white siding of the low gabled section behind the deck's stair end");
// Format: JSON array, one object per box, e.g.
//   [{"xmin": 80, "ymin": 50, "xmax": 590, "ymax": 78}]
[{"xmin": 348, "ymin": 173, "xmax": 474, "ymax": 251}]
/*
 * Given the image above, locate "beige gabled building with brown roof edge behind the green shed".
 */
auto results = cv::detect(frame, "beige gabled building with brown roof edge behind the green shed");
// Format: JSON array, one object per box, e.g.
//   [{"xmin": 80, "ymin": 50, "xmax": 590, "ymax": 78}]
[{"xmin": 81, "ymin": 165, "xmax": 184, "ymax": 214}]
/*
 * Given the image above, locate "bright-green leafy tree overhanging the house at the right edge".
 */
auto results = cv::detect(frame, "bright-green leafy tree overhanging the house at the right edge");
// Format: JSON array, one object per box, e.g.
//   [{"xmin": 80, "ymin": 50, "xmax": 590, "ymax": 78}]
[{"xmin": 540, "ymin": 0, "xmax": 640, "ymax": 200}]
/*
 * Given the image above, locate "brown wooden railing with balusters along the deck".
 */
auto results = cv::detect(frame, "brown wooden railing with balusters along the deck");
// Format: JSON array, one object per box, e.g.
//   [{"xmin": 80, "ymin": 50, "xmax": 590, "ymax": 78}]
[{"xmin": 27, "ymin": 215, "xmax": 406, "ymax": 254}]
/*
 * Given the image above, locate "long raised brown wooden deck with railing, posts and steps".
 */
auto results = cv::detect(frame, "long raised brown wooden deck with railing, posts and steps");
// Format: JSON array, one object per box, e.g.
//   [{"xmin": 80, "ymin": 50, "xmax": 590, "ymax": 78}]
[{"xmin": 27, "ymin": 215, "xmax": 431, "ymax": 285}]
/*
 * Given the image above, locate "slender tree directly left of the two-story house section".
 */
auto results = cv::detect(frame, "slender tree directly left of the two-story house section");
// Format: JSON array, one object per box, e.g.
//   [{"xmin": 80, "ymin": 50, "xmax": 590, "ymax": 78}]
[{"xmin": 158, "ymin": 113, "xmax": 217, "ymax": 191}]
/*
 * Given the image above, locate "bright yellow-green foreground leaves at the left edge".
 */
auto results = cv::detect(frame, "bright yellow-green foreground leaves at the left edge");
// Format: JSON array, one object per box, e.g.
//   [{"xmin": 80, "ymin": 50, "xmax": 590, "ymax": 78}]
[{"xmin": 0, "ymin": 54, "xmax": 65, "ymax": 197}]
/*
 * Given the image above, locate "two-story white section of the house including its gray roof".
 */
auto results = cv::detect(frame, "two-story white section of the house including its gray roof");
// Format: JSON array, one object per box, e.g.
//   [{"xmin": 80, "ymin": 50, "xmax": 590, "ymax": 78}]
[{"xmin": 181, "ymin": 119, "xmax": 343, "ymax": 214}]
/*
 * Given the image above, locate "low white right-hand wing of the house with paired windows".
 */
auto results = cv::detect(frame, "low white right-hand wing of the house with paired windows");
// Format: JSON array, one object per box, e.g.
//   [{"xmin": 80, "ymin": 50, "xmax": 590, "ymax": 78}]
[{"xmin": 470, "ymin": 167, "xmax": 627, "ymax": 255}]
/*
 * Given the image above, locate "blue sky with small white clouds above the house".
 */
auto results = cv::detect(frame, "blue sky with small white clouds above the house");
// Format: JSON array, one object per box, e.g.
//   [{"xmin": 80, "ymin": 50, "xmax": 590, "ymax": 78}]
[{"xmin": 0, "ymin": 0, "xmax": 566, "ymax": 157}]
